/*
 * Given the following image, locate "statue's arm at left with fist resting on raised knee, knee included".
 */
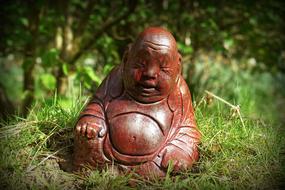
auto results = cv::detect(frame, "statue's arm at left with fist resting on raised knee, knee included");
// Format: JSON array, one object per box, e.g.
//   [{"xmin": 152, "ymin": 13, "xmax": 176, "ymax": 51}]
[{"xmin": 73, "ymin": 76, "xmax": 107, "ymax": 170}]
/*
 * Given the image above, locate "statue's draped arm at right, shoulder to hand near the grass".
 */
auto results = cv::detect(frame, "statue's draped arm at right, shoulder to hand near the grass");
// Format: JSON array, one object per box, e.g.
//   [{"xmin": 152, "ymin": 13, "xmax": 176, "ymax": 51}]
[{"xmin": 161, "ymin": 77, "xmax": 201, "ymax": 171}]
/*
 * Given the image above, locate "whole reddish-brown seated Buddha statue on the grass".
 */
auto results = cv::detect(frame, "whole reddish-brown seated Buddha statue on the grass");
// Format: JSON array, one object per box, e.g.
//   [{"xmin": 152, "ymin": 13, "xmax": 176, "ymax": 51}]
[{"xmin": 74, "ymin": 28, "xmax": 200, "ymax": 176}]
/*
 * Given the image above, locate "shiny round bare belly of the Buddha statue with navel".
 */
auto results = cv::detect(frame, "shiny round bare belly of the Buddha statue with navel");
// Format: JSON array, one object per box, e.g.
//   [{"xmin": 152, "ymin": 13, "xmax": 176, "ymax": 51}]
[{"xmin": 109, "ymin": 113, "xmax": 164, "ymax": 155}]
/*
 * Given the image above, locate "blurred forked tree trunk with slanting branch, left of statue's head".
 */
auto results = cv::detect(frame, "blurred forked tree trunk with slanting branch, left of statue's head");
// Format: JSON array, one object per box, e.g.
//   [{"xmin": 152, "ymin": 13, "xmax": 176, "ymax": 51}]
[{"xmin": 56, "ymin": 0, "xmax": 137, "ymax": 94}]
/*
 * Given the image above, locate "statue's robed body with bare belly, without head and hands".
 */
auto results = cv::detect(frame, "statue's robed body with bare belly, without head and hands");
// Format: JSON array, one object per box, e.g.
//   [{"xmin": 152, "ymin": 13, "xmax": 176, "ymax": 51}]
[{"xmin": 74, "ymin": 66, "xmax": 200, "ymax": 176}]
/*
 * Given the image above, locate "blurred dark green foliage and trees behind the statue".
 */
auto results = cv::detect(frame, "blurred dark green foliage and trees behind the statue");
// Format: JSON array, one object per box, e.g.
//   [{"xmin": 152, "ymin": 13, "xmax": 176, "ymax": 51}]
[{"xmin": 0, "ymin": 0, "xmax": 285, "ymax": 116}]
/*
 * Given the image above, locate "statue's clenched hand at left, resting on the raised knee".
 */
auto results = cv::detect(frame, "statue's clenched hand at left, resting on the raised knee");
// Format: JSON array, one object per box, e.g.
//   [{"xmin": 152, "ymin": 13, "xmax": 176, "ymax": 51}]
[{"xmin": 75, "ymin": 117, "xmax": 107, "ymax": 139}]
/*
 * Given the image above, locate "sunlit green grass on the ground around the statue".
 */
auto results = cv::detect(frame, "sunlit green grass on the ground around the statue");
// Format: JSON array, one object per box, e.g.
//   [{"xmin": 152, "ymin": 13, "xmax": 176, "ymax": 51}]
[{"xmin": 0, "ymin": 61, "xmax": 285, "ymax": 189}]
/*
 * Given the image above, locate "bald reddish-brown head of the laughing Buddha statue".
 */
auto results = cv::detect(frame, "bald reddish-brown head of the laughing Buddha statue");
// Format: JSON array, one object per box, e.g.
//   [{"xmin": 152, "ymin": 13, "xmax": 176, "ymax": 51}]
[{"xmin": 123, "ymin": 27, "xmax": 181, "ymax": 103}]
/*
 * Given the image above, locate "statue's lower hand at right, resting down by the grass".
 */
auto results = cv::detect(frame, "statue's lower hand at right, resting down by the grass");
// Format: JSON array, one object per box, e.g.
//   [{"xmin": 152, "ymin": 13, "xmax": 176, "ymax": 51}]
[{"xmin": 161, "ymin": 145, "xmax": 192, "ymax": 172}]
